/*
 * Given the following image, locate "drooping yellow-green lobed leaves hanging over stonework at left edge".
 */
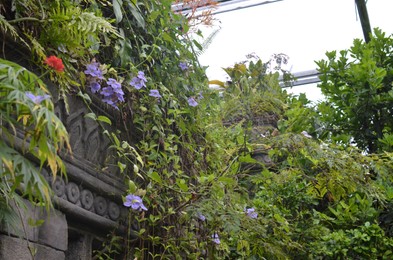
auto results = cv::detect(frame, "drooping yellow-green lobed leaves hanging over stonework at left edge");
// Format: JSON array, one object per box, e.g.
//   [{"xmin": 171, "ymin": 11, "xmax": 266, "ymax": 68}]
[{"xmin": 0, "ymin": 59, "xmax": 70, "ymax": 225}]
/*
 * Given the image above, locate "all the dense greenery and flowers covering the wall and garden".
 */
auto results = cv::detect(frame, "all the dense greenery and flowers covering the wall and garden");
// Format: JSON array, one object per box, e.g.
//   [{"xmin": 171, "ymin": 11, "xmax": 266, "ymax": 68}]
[{"xmin": 0, "ymin": 0, "xmax": 393, "ymax": 259}]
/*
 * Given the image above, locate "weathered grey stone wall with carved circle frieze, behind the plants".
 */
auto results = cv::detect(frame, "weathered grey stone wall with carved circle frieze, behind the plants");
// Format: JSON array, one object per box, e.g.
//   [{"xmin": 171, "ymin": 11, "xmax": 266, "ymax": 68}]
[{"xmin": 0, "ymin": 40, "xmax": 128, "ymax": 260}]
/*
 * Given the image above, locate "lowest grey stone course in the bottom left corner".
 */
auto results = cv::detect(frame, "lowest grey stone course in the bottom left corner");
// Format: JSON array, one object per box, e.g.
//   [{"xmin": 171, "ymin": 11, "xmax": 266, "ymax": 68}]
[{"xmin": 0, "ymin": 235, "xmax": 65, "ymax": 260}]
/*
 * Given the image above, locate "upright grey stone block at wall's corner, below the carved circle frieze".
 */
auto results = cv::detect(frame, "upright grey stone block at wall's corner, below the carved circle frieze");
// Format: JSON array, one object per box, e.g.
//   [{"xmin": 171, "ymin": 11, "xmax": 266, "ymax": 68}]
[{"xmin": 38, "ymin": 210, "xmax": 68, "ymax": 251}]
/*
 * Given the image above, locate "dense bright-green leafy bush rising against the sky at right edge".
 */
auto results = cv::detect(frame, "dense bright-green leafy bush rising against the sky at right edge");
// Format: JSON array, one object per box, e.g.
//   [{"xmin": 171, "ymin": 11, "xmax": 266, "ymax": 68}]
[{"xmin": 317, "ymin": 29, "xmax": 393, "ymax": 153}]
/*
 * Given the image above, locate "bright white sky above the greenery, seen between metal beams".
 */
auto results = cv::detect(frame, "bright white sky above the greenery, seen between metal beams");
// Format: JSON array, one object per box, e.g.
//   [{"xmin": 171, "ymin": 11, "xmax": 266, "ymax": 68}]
[{"xmin": 199, "ymin": 0, "xmax": 393, "ymax": 101}]
